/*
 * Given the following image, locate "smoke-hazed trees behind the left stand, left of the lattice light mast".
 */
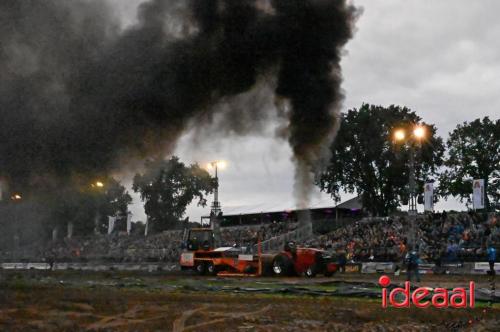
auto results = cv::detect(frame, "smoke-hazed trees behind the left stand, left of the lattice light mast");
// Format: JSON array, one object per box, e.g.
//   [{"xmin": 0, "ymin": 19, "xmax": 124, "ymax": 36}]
[{"xmin": 0, "ymin": 156, "xmax": 216, "ymax": 249}]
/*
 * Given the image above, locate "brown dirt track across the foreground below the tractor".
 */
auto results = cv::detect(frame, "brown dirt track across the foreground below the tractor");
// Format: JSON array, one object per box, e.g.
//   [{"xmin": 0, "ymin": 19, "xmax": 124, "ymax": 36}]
[{"xmin": 0, "ymin": 272, "xmax": 500, "ymax": 331}]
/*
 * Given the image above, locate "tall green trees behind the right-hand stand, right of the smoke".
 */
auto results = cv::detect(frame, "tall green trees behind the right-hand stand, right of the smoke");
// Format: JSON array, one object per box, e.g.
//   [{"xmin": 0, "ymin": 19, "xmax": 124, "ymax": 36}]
[{"xmin": 316, "ymin": 104, "xmax": 500, "ymax": 216}]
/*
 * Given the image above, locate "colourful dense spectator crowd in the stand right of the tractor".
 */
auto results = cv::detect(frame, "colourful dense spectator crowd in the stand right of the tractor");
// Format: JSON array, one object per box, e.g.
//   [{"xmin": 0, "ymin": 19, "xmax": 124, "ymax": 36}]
[{"xmin": 315, "ymin": 212, "xmax": 500, "ymax": 264}]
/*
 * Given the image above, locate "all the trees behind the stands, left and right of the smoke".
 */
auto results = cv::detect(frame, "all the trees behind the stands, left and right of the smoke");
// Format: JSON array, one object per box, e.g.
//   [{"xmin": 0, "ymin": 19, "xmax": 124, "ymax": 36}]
[{"xmin": 0, "ymin": 104, "xmax": 494, "ymax": 242}]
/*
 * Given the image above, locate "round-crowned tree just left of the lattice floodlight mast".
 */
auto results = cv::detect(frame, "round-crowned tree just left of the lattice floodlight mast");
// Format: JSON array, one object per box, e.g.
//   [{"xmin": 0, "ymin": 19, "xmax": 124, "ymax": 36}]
[{"xmin": 133, "ymin": 156, "xmax": 216, "ymax": 231}]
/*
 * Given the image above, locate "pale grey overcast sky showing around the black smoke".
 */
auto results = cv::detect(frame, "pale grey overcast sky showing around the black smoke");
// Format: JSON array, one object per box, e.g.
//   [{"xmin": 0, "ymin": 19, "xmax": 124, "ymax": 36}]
[{"xmin": 112, "ymin": 0, "xmax": 500, "ymax": 220}]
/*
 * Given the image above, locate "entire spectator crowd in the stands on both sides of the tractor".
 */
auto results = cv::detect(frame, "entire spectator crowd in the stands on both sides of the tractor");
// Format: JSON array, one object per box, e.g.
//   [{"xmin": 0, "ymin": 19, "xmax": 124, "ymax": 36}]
[{"xmin": 0, "ymin": 212, "xmax": 500, "ymax": 264}]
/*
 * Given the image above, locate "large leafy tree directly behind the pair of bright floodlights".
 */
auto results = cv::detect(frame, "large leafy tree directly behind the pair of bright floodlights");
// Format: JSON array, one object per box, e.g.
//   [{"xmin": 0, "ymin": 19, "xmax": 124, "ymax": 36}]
[{"xmin": 317, "ymin": 104, "xmax": 444, "ymax": 215}]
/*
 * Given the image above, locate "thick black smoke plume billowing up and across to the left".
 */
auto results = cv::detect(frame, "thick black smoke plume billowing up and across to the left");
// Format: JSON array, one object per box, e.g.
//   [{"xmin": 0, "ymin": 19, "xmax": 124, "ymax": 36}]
[{"xmin": 0, "ymin": 0, "xmax": 357, "ymax": 204}]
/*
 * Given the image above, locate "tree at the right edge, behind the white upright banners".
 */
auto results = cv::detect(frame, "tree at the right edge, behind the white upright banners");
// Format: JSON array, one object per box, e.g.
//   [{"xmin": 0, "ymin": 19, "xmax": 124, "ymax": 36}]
[{"xmin": 439, "ymin": 117, "xmax": 500, "ymax": 208}]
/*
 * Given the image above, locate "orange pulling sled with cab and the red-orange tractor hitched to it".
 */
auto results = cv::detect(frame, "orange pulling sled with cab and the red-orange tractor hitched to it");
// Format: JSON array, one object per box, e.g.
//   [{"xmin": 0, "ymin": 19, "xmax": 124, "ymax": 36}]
[{"xmin": 180, "ymin": 228, "xmax": 338, "ymax": 277}]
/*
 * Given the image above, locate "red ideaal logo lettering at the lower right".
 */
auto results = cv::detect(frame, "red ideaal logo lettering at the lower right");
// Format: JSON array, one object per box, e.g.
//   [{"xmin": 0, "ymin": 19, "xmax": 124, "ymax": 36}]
[{"xmin": 378, "ymin": 276, "xmax": 475, "ymax": 308}]
